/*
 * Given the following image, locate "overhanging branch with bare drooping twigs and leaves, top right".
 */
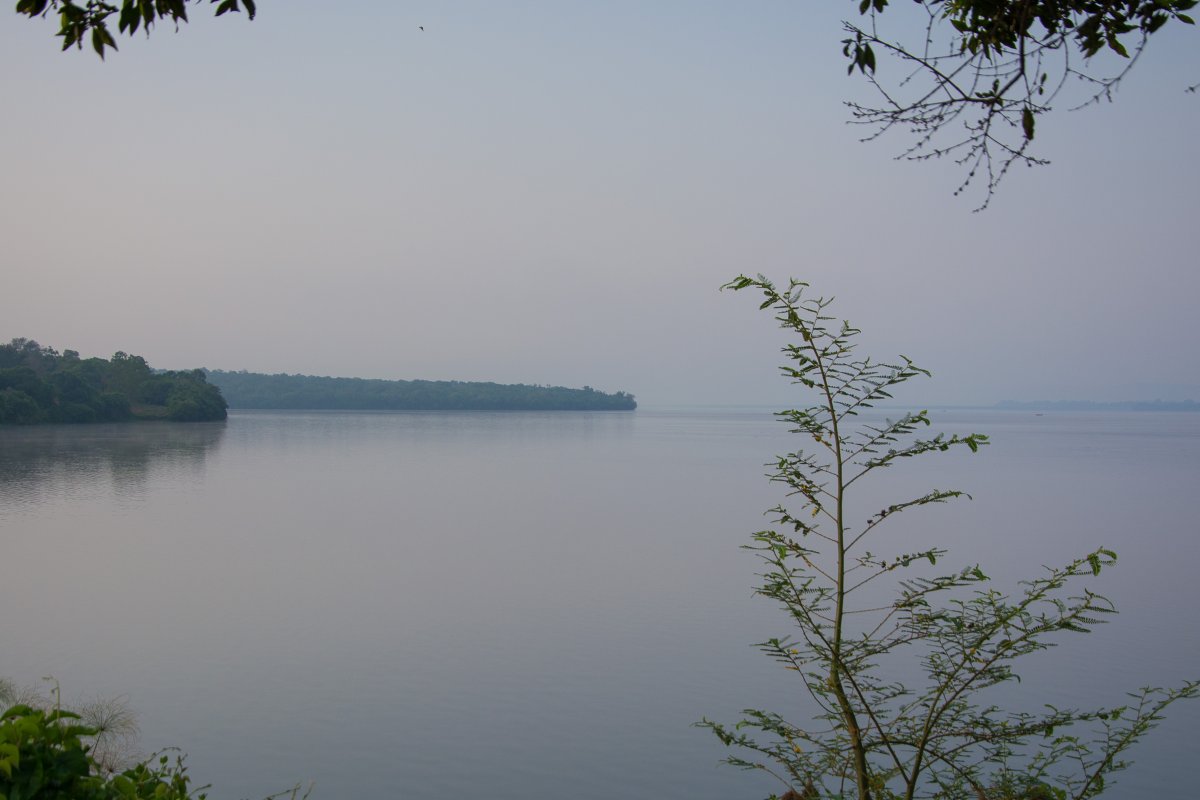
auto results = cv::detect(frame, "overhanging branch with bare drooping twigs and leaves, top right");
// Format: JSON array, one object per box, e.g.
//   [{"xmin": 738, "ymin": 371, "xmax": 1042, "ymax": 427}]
[{"xmin": 842, "ymin": 0, "xmax": 1198, "ymax": 210}]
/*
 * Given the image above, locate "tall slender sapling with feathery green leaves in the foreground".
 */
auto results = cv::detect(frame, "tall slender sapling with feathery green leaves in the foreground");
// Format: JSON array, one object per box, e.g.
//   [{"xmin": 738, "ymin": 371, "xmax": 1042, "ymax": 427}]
[{"xmin": 700, "ymin": 276, "xmax": 1200, "ymax": 800}]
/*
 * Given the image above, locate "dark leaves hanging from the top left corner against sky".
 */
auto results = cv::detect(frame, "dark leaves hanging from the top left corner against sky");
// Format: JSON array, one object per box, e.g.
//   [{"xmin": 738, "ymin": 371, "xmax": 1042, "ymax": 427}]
[{"xmin": 17, "ymin": 0, "xmax": 258, "ymax": 59}]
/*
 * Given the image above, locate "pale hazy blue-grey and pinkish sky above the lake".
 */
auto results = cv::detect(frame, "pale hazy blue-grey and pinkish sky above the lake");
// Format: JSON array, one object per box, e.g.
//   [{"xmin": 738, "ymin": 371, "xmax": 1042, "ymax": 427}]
[{"xmin": 0, "ymin": 0, "xmax": 1200, "ymax": 405}]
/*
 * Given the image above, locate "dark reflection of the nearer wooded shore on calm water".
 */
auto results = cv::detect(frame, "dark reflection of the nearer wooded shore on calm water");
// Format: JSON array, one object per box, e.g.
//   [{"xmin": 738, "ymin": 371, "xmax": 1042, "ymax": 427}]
[{"xmin": 0, "ymin": 422, "xmax": 226, "ymax": 509}]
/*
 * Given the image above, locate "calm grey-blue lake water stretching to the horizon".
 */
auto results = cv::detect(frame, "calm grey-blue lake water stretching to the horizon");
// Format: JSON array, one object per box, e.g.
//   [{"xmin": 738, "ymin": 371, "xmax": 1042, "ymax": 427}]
[{"xmin": 0, "ymin": 409, "xmax": 1200, "ymax": 800}]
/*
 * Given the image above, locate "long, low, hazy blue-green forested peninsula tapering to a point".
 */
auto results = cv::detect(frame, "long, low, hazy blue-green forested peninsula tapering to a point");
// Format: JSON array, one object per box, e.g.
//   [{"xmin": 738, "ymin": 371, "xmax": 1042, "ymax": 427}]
[{"xmin": 208, "ymin": 369, "xmax": 637, "ymax": 411}]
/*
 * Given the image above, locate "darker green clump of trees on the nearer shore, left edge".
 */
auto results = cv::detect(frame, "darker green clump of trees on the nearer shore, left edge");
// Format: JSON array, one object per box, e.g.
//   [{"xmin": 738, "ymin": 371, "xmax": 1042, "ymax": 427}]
[{"xmin": 0, "ymin": 338, "xmax": 226, "ymax": 425}]
